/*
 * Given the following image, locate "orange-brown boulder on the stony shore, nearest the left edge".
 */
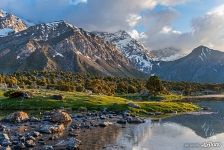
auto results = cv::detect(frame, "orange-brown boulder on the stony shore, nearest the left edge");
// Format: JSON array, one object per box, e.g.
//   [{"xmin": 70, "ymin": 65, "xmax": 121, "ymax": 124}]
[{"xmin": 3, "ymin": 111, "xmax": 29, "ymax": 123}]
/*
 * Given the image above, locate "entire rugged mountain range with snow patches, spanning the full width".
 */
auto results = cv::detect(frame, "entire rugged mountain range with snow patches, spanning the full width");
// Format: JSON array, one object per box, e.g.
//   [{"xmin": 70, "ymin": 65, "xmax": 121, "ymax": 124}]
[{"xmin": 0, "ymin": 11, "xmax": 224, "ymax": 83}]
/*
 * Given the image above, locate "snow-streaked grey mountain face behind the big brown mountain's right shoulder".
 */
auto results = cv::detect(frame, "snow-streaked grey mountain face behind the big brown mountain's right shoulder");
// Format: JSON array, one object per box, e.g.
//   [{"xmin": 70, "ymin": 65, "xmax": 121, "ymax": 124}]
[{"xmin": 93, "ymin": 31, "xmax": 152, "ymax": 74}]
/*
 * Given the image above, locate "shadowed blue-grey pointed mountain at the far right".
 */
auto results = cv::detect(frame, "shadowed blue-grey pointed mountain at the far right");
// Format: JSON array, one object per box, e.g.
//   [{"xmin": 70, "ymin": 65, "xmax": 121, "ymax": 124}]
[{"xmin": 153, "ymin": 46, "xmax": 224, "ymax": 83}]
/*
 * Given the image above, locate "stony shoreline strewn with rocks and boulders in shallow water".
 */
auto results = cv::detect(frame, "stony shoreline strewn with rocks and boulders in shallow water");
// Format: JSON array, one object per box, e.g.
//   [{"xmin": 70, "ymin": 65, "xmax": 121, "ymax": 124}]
[{"xmin": 0, "ymin": 110, "xmax": 145, "ymax": 150}]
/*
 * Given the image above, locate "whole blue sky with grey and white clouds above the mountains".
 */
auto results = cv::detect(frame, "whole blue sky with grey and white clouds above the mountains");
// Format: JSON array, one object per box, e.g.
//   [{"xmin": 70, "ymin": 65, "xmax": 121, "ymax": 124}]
[{"xmin": 0, "ymin": 0, "xmax": 224, "ymax": 51}]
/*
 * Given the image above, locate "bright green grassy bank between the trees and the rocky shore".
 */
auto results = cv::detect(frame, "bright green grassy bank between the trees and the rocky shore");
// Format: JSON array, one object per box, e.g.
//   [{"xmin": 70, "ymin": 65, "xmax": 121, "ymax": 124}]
[{"xmin": 0, "ymin": 90, "xmax": 199, "ymax": 114}]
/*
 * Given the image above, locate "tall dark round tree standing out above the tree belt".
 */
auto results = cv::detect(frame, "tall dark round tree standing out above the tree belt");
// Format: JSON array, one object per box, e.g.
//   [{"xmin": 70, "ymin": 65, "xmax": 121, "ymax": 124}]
[{"xmin": 146, "ymin": 76, "xmax": 164, "ymax": 96}]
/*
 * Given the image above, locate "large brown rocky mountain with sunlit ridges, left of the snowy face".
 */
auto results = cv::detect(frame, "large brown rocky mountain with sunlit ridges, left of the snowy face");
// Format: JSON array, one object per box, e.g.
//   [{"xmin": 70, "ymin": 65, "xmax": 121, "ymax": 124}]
[{"xmin": 0, "ymin": 21, "xmax": 142, "ymax": 77}]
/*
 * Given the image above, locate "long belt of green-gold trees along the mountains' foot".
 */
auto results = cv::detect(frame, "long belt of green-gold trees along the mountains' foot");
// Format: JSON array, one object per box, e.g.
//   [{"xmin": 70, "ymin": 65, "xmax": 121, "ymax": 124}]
[{"xmin": 0, "ymin": 71, "xmax": 224, "ymax": 95}]
